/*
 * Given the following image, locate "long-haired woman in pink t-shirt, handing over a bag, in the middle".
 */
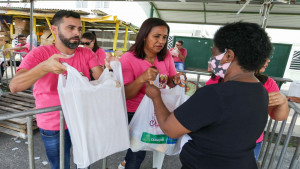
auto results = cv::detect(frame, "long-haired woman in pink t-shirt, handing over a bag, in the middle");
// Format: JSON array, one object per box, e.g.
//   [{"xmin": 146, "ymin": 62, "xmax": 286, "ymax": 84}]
[{"xmin": 118, "ymin": 18, "xmax": 180, "ymax": 169}]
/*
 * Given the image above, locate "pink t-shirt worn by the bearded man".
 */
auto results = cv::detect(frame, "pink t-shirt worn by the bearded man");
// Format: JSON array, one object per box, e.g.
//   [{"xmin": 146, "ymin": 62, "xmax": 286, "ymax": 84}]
[{"xmin": 18, "ymin": 45, "xmax": 98, "ymax": 130}]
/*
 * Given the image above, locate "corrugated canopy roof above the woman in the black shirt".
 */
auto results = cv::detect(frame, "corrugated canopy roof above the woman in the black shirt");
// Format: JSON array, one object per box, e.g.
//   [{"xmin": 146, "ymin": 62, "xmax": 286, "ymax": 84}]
[{"xmin": 151, "ymin": 0, "xmax": 300, "ymax": 29}]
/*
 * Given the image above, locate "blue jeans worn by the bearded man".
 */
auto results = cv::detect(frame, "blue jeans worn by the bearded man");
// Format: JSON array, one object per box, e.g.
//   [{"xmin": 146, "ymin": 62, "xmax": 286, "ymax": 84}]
[{"xmin": 40, "ymin": 128, "xmax": 72, "ymax": 169}]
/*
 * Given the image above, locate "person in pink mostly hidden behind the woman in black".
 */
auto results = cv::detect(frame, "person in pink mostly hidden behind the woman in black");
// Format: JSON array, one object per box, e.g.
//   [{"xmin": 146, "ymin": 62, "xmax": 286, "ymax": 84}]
[{"xmin": 205, "ymin": 59, "xmax": 289, "ymax": 160}]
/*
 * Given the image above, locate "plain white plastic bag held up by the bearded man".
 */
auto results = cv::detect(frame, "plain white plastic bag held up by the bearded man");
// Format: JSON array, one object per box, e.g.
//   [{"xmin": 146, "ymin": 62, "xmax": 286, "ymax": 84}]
[{"xmin": 58, "ymin": 62, "xmax": 130, "ymax": 168}]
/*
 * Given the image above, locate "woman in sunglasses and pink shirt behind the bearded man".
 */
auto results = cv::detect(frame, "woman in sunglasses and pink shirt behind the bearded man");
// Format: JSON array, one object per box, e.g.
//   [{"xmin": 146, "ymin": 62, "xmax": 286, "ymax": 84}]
[{"xmin": 80, "ymin": 32, "xmax": 106, "ymax": 66}]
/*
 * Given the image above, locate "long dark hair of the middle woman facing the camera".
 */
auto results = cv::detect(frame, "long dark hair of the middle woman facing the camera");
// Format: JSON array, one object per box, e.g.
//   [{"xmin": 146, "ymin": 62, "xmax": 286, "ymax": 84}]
[{"xmin": 129, "ymin": 18, "xmax": 170, "ymax": 61}]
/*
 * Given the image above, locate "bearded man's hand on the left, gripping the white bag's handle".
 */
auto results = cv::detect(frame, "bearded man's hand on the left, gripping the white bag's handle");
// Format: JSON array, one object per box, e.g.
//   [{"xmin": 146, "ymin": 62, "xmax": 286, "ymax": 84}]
[{"xmin": 43, "ymin": 54, "xmax": 69, "ymax": 74}]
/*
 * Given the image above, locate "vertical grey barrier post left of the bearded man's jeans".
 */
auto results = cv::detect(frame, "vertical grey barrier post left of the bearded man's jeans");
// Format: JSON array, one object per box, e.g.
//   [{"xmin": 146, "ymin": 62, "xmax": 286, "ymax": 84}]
[{"xmin": 26, "ymin": 116, "xmax": 35, "ymax": 169}]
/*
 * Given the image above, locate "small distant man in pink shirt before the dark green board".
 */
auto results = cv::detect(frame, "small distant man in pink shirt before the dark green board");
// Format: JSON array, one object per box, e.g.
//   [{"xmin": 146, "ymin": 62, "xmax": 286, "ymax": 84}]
[{"xmin": 170, "ymin": 40, "xmax": 187, "ymax": 70}]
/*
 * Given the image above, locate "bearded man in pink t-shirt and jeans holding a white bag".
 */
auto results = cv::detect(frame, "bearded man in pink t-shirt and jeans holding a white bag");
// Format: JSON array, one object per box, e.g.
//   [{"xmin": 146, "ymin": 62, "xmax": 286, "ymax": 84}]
[{"xmin": 9, "ymin": 10, "xmax": 103, "ymax": 169}]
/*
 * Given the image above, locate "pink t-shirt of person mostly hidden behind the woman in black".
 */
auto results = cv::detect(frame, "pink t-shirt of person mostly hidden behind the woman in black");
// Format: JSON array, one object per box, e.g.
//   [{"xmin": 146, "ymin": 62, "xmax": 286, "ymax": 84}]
[{"xmin": 205, "ymin": 76, "xmax": 279, "ymax": 143}]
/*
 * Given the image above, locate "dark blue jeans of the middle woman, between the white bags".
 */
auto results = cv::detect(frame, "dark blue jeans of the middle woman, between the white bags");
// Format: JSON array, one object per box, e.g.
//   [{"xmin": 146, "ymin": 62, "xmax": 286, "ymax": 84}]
[{"xmin": 125, "ymin": 112, "xmax": 146, "ymax": 169}]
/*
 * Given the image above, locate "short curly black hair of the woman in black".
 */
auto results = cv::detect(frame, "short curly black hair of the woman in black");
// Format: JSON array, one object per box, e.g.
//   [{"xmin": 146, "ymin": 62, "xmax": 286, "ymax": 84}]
[{"xmin": 214, "ymin": 22, "xmax": 272, "ymax": 71}]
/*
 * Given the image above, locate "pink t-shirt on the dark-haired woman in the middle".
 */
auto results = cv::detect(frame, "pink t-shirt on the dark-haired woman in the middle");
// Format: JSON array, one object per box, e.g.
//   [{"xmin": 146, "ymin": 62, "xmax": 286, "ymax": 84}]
[{"xmin": 120, "ymin": 52, "xmax": 177, "ymax": 112}]
